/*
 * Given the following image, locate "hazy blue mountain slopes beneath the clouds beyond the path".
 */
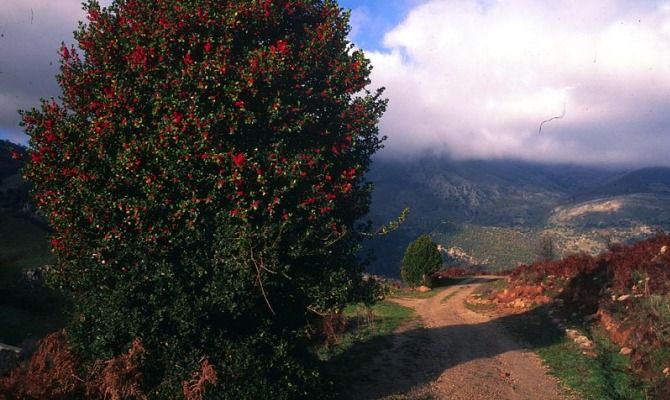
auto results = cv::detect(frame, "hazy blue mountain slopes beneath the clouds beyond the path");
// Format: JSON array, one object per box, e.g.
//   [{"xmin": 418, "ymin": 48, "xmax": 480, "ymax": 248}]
[{"xmin": 364, "ymin": 158, "xmax": 670, "ymax": 276}]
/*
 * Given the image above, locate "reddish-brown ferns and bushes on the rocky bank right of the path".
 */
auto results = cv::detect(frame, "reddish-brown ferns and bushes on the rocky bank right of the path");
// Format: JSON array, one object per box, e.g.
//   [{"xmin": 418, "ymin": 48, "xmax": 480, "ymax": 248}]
[{"xmin": 494, "ymin": 234, "xmax": 670, "ymax": 398}]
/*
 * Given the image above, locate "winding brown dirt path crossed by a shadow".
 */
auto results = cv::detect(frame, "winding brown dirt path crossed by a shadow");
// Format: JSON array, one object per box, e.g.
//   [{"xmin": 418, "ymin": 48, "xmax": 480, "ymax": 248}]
[{"xmin": 351, "ymin": 279, "xmax": 574, "ymax": 400}]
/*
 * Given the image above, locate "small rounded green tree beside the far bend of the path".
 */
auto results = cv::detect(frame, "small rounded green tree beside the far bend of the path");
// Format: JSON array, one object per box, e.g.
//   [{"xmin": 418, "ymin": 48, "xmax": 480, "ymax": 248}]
[{"xmin": 400, "ymin": 234, "xmax": 442, "ymax": 286}]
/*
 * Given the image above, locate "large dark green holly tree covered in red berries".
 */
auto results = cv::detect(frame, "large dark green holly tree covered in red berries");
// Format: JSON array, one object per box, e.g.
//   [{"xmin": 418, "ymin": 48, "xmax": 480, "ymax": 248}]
[{"xmin": 22, "ymin": 0, "xmax": 386, "ymax": 399}]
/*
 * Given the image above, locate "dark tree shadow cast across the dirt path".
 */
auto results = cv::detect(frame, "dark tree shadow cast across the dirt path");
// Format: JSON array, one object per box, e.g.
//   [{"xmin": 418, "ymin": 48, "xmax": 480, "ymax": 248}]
[{"xmin": 328, "ymin": 304, "xmax": 564, "ymax": 400}]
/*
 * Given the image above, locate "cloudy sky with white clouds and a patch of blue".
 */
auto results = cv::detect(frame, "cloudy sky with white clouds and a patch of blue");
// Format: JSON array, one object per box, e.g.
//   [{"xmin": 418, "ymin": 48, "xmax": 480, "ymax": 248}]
[{"xmin": 0, "ymin": 0, "xmax": 670, "ymax": 166}]
